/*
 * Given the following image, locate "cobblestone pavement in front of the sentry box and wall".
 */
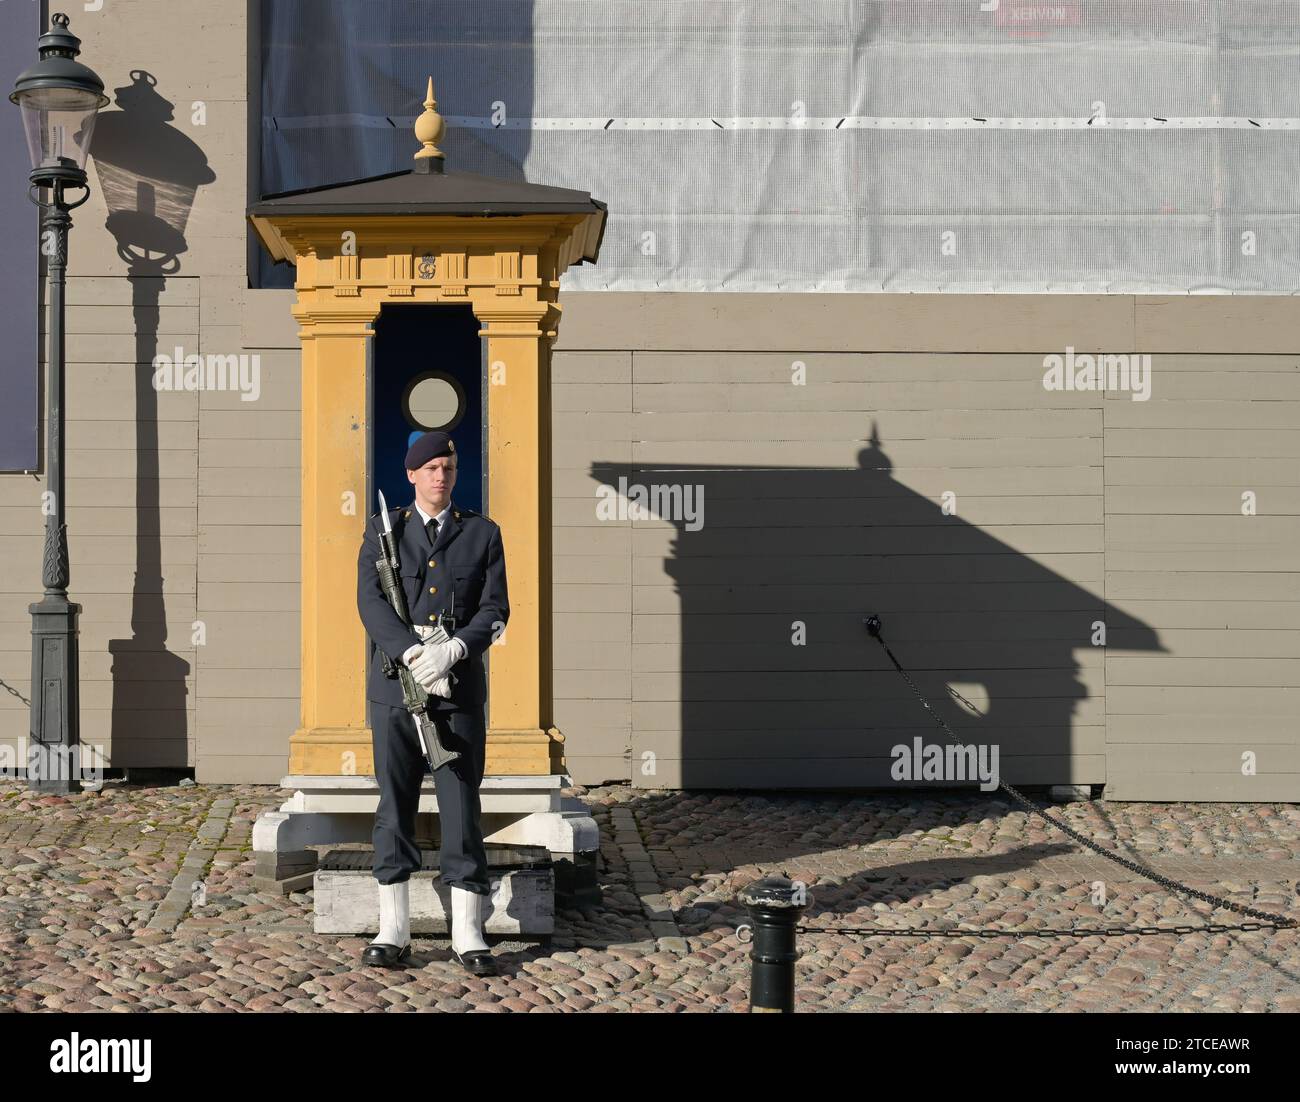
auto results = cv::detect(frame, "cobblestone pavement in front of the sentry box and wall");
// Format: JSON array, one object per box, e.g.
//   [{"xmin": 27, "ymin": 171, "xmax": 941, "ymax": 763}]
[{"xmin": 0, "ymin": 781, "xmax": 1300, "ymax": 1012}]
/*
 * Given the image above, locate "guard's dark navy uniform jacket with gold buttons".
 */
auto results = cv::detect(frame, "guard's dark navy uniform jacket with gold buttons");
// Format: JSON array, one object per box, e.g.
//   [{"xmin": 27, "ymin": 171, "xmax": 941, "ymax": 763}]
[{"xmin": 356, "ymin": 500, "xmax": 510, "ymax": 715}]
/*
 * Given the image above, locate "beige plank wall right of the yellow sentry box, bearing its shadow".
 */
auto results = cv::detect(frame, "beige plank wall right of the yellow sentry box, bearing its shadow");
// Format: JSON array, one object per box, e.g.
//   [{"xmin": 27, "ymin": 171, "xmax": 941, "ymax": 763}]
[{"xmin": 554, "ymin": 295, "xmax": 1300, "ymax": 799}]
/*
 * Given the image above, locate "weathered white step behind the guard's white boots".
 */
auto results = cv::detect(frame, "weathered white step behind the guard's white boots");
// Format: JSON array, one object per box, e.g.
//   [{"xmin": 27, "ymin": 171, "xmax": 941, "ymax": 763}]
[{"xmin": 313, "ymin": 843, "xmax": 555, "ymax": 937}]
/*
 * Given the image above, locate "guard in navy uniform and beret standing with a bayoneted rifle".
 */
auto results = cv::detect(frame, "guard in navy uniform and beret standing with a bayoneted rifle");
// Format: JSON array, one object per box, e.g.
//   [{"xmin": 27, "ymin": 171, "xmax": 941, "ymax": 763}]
[{"xmin": 356, "ymin": 431, "xmax": 510, "ymax": 976}]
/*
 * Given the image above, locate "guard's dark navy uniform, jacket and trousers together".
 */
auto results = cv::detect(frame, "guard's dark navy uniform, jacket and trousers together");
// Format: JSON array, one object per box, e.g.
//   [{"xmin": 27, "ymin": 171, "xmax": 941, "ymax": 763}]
[{"xmin": 356, "ymin": 502, "xmax": 510, "ymax": 895}]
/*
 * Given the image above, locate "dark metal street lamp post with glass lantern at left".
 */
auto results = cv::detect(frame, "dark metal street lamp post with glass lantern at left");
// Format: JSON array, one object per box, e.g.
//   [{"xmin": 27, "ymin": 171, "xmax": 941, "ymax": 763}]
[{"xmin": 9, "ymin": 13, "xmax": 108, "ymax": 793}]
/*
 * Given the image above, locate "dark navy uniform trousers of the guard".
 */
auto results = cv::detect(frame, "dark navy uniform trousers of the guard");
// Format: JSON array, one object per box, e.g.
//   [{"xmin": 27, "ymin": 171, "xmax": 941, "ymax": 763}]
[{"xmin": 367, "ymin": 700, "xmax": 491, "ymax": 895}]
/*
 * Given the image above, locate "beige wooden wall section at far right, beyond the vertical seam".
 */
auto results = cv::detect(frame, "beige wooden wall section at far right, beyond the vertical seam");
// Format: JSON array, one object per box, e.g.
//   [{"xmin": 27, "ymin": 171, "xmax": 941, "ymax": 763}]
[{"xmin": 1105, "ymin": 298, "xmax": 1300, "ymax": 801}]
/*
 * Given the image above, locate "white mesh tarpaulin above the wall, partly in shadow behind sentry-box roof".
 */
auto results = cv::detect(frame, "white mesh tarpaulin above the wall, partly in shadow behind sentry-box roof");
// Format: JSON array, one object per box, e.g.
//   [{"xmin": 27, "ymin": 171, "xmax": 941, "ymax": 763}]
[{"xmin": 261, "ymin": 0, "xmax": 1300, "ymax": 294}]
